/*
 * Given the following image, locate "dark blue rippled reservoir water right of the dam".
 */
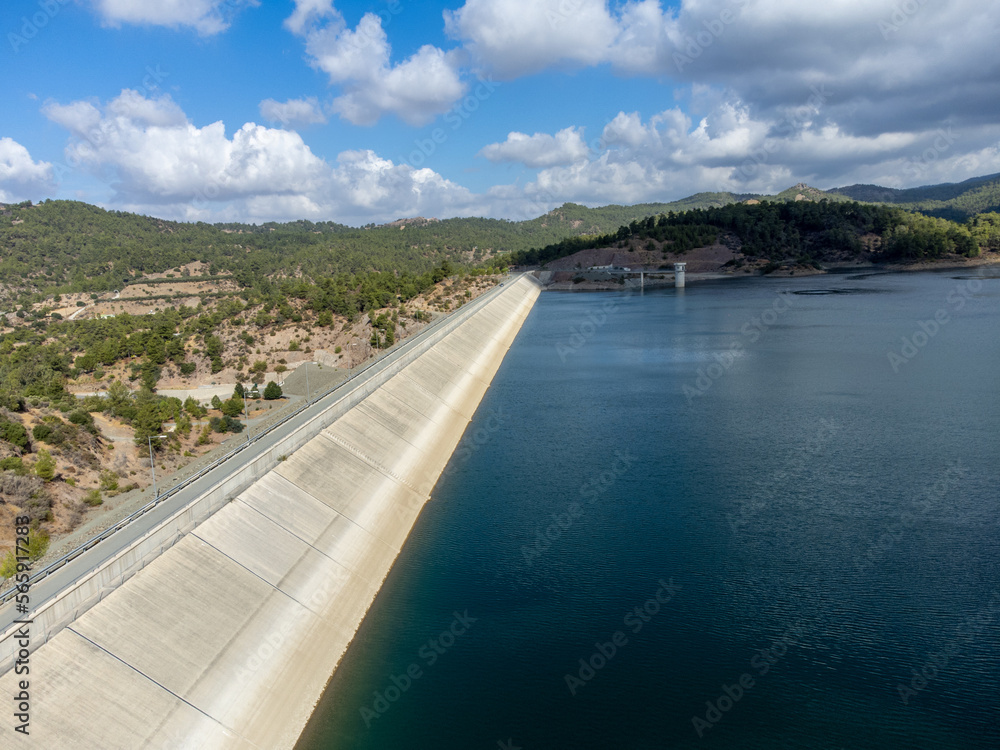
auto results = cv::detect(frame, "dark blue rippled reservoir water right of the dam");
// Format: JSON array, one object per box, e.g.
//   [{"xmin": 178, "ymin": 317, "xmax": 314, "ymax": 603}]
[{"xmin": 299, "ymin": 272, "xmax": 1000, "ymax": 750}]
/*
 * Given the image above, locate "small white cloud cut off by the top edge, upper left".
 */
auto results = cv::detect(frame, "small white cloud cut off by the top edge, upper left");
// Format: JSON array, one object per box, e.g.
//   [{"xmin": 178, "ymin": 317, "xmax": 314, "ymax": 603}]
[{"xmin": 94, "ymin": 0, "xmax": 259, "ymax": 36}]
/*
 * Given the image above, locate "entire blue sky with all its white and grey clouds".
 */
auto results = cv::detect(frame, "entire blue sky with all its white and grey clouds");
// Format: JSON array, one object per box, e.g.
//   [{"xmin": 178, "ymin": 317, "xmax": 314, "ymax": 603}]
[{"xmin": 0, "ymin": 0, "xmax": 1000, "ymax": 226}]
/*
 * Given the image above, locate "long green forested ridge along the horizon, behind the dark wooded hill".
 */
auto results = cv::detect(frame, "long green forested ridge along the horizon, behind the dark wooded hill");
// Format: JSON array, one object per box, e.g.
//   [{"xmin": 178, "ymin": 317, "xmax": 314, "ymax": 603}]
[{"xmin": 0, "ymin": 174, "xmax": 1000, "ymax": 299}]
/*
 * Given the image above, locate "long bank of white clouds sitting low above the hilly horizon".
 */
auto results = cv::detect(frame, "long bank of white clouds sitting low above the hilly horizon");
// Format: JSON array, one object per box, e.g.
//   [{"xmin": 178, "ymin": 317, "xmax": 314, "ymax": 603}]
[{"xmin": 31, "ymin": 91, "xmax": 1000, "ymax": 224}]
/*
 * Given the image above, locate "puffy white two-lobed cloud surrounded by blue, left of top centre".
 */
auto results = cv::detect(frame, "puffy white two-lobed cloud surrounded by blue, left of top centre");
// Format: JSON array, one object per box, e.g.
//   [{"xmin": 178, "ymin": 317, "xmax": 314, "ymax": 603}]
[{"xmin": 286, "ymin": 5, "xmax": 466, "ymax": 125}]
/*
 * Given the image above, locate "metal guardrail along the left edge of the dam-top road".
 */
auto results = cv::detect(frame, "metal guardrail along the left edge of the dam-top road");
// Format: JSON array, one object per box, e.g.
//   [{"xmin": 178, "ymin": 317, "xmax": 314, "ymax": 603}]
[{"xmin": 0, "ymin": 277, "xmax": 509, "ymax": 606}]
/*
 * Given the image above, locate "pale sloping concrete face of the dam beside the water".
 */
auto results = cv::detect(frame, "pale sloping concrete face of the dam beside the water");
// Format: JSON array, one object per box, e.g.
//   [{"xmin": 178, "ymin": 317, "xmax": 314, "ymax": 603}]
[{"xmin": 0, "ymin": 277, "xmax": 539, "ymax": 750}]
